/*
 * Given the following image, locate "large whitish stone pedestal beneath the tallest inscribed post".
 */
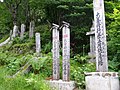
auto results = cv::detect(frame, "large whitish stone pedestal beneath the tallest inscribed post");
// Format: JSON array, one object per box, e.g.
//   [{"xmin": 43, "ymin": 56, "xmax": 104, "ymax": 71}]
[{"xmin": 85, "ymin": 72, "xmax": 120, "ymax": 90}]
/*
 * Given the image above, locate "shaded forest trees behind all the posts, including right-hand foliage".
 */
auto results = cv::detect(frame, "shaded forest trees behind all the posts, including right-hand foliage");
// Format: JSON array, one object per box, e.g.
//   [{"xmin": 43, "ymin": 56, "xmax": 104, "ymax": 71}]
[{"xmin": 0, "ymin": 0, "xmax": 120, "ymax": 60}]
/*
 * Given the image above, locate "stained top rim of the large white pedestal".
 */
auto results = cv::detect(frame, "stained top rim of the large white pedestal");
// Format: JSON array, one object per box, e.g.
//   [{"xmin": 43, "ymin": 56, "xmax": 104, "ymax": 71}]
[{"xmin": 84, "ymin": 72, "xmax": 119, "ymax": 77}]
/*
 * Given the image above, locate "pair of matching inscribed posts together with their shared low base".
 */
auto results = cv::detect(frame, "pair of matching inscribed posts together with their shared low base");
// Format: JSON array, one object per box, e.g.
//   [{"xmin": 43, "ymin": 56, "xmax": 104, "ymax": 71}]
[{"xmin": 50, "ymin": 21, "xmax": 75, "ymax": 90}]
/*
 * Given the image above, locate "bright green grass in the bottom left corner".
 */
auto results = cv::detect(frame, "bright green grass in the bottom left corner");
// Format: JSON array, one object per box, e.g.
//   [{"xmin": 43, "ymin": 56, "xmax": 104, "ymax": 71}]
[{"xmin": 0, "ymin": 67, "xmax": 51, "ymax": 90}]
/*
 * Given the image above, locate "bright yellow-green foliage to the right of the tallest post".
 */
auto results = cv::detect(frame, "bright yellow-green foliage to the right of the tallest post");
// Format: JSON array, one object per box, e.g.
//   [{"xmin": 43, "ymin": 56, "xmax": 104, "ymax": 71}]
[{"xmin": 106, "ymin": 2, "xmax": 120, "ymax": 72}]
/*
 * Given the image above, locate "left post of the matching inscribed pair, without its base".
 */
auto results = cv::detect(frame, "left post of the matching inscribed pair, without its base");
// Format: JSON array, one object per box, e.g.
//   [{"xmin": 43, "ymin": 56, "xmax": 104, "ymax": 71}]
[{"xmin": 52, "ymin": 24, "xmax": 60, "ymax": 80}]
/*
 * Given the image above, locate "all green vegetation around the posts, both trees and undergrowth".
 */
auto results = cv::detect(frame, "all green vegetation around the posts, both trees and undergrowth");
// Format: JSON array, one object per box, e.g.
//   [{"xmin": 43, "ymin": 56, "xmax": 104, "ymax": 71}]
[{"xmin": 0, "ymin": 0, "xmax": 120, "ymax": 90}]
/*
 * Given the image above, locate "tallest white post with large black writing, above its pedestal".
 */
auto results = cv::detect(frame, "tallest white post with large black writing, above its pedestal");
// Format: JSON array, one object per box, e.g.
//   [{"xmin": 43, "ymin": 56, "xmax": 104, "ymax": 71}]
[{"xmin": 93, "ymin": 0, "xmax": 108, "ymax": 72}]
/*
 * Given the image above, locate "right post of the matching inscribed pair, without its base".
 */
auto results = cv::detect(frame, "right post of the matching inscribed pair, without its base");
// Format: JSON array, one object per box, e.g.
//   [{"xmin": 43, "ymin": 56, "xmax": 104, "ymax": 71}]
[{"xmin": 62, "ymin": 22, "xmax": 70, "ymax": 81}]
